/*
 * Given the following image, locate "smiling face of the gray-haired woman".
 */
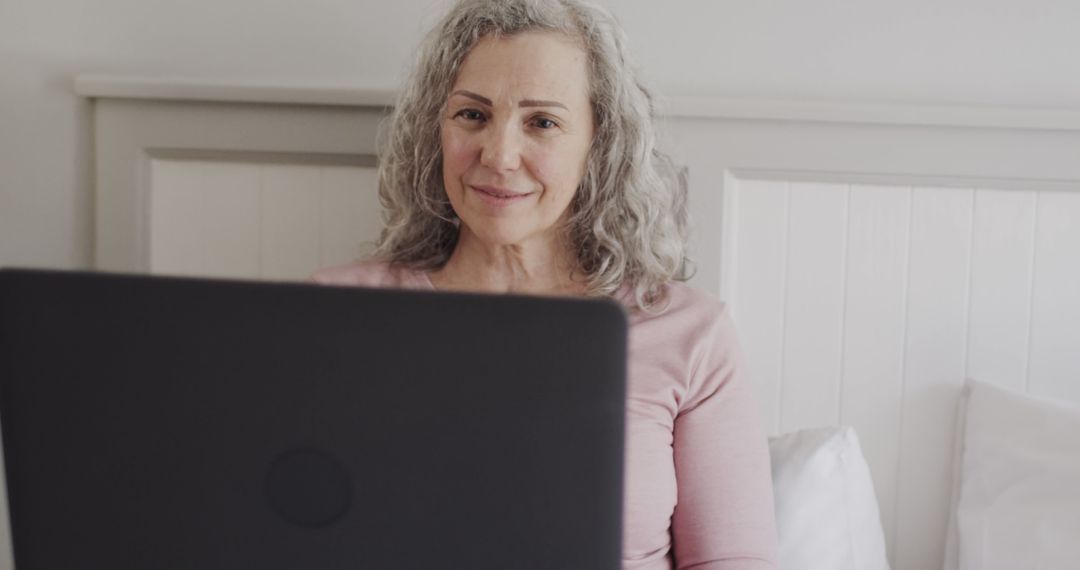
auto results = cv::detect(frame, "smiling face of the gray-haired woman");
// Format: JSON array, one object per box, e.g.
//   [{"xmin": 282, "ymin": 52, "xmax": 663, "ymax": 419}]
[{"xmin": 442, "ymin": 32, "xmax": 593, "ymax": 245}]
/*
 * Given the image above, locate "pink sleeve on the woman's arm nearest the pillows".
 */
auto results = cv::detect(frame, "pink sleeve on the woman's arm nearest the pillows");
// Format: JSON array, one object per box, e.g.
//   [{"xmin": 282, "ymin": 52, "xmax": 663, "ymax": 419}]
[{"xmin": 672, "ymin": 308, "xmax": 777, "ymax": 570}]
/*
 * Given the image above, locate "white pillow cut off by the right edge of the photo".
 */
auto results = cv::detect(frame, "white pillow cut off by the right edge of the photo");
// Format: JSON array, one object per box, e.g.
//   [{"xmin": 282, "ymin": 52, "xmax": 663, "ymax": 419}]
[{"xmin": 946, "ymin": 380, "xmax": 1080, "ymax": 570}]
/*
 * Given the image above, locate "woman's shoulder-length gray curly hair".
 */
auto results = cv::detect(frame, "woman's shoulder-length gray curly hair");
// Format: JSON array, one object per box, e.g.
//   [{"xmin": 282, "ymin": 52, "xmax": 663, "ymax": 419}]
[{"xmin": 374, "ymin": 0, "xmax": 689, "ymax": 312}]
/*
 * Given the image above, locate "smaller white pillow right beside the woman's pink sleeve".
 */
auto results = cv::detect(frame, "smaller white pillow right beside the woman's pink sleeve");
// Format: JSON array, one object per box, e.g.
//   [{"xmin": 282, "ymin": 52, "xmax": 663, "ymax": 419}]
[{"xmin": 769, "ymin": 428, "xmax": 889, "ymax": 570}]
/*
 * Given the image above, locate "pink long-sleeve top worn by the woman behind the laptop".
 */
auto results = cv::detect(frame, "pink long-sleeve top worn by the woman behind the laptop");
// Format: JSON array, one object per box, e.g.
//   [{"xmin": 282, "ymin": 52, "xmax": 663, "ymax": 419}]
[{"xmin": 311, "ymin": 260, "xmax": 777, "ymax": 570}]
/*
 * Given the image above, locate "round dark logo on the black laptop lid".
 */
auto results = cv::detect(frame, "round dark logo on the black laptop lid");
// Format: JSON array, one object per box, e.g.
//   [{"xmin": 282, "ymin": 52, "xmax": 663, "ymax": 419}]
[{"xmin": 266, "ymin": 447, "xmax": 352, "ymax": 528}]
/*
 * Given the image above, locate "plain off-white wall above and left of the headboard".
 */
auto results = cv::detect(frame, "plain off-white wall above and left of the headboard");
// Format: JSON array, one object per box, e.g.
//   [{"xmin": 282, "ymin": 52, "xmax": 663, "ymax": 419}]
[{"xmin": 0, "ymin": 0, "xmax": 1080, "ymax": 268}]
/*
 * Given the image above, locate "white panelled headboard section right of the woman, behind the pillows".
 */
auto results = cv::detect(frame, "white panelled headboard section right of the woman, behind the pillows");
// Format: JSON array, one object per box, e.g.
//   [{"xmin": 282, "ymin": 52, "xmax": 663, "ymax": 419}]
[{"xmin": 656, "ymin": 105, "xmax": 1080, "ymax": 570}]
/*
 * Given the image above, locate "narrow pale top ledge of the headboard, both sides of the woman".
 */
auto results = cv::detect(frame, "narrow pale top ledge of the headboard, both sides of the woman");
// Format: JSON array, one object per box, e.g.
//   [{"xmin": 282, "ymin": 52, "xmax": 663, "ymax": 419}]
[{"xmin": 75, "ymin": 76, "xmax": 1080, "ymax": 131}]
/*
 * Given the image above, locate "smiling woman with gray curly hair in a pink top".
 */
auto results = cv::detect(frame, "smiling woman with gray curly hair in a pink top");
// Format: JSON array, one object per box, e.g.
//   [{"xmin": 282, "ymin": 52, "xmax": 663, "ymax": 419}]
[{"xmin": 313, "ymin": 0, "xmax": 775, "ymax": 570}]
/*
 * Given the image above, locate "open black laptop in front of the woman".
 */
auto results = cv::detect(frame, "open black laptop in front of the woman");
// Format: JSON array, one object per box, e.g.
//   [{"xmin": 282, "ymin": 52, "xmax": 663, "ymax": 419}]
[{"xmin": 0, "ymin": 270, "xmax": 626, "ymax": 570}]
